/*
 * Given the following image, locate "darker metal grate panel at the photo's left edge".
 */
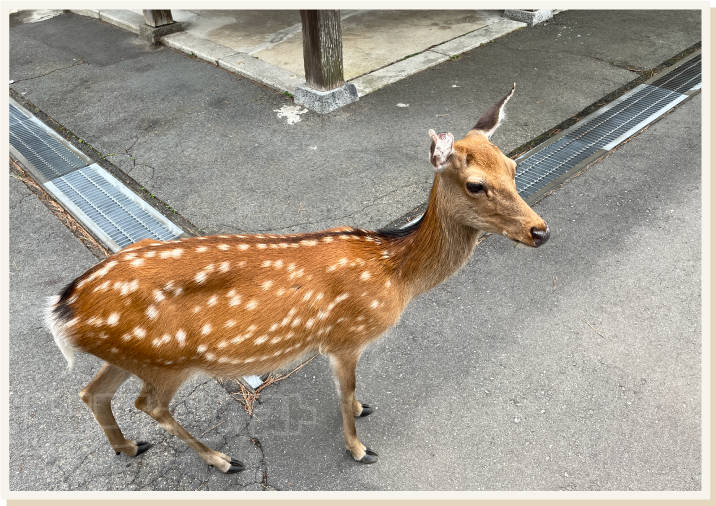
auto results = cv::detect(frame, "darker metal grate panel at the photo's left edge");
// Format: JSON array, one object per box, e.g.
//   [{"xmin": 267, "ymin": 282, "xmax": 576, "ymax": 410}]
[{"xmin": 10, "ymin": 118, "xmax": 87, "ymax": 181}]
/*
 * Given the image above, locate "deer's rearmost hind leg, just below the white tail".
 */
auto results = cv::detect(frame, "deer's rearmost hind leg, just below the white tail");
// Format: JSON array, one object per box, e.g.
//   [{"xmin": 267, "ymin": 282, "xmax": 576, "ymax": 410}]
[{"xmin": 80, "ymin": 363, "xmax": 152, "ymax": 457}]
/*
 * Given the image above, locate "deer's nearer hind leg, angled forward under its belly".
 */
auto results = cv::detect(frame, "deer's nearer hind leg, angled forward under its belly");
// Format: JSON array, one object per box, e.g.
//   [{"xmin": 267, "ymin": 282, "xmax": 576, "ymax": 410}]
[{"xmin": 134, "ymin": 374, "xmax": 245, "ymax": 474}]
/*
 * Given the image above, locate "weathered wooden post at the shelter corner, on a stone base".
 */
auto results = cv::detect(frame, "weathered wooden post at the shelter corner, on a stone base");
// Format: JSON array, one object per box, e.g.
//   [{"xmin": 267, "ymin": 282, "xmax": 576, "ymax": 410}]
[{"xmin": 300, "ymin": 10, "xmax": 345, "ymax": 91}]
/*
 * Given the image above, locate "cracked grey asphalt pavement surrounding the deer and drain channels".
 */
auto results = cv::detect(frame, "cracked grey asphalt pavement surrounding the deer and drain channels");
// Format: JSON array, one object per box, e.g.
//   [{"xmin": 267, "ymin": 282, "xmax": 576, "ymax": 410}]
[{"xmin": 9, "ymin": 11, "xmax": 703, "ymax": 491}]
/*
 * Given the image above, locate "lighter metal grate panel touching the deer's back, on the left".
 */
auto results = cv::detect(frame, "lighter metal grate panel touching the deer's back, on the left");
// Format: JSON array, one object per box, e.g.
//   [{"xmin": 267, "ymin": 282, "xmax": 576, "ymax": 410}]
[{"xmin": 45, "ymin": 164, "xmax": 182, "ymax": 252}]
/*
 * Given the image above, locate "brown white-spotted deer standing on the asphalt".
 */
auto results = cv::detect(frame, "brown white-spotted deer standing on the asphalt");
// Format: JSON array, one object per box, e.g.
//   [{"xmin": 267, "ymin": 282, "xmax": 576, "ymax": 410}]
[{"xmin": 45, "ymin": 84, "xmax": 550, "ymax": 474}]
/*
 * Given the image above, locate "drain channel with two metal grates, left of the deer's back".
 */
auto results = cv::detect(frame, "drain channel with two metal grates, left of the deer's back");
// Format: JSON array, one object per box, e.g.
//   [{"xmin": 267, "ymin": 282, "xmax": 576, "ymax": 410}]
[{"xmin": 10, "ymin": 98, "xmax": 188, "ymax": 252}]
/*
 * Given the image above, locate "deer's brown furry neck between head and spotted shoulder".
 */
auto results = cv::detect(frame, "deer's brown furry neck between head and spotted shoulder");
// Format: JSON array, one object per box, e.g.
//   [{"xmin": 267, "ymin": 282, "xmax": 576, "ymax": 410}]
[{"xmin": 386, "ymin": 176, "xmax": 480, "ymax": 300}]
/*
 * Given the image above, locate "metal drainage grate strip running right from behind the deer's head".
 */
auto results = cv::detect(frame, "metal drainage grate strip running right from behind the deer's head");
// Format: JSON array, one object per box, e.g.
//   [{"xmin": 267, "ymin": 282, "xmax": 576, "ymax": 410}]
[{"xmin": 515, "ymin": 54, "xmax": 701, "ymax": 202}]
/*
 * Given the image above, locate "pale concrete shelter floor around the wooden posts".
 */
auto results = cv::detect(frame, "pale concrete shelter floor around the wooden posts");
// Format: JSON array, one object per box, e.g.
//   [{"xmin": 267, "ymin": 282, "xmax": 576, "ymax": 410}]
[{"xmin": 65, "ymin": 9, "xmax": 526, "ymax": 96}]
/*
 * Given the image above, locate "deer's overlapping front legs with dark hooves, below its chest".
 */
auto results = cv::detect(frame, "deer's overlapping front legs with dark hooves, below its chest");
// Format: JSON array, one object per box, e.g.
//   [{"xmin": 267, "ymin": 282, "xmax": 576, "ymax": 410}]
[{"xmin": 330, "ymin": 353, "xmax": 378, "ymax": 464}]
